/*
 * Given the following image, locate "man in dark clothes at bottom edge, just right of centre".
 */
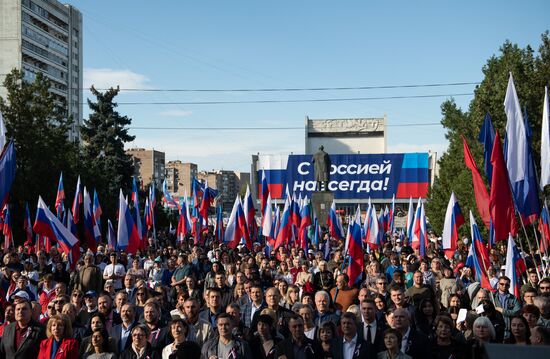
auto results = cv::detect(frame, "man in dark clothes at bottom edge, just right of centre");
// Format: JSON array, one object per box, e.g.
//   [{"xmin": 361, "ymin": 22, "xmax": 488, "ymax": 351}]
[{"xmin": 276, "ymin": 314, "xmax": 322, "ymax": 359}]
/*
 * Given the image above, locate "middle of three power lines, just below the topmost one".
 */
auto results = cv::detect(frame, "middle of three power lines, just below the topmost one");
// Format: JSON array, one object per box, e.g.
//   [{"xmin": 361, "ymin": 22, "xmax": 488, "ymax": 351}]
[{"xmin": 102, "ymin": 93, "xmax": 474, "ymax": 106}]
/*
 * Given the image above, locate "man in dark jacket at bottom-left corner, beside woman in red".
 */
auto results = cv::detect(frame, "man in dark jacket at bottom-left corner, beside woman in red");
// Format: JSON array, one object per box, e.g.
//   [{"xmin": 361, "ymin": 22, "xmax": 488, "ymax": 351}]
[{"xmin": 0, "ymin": 299, "xmax": 46, "ymax": 359}]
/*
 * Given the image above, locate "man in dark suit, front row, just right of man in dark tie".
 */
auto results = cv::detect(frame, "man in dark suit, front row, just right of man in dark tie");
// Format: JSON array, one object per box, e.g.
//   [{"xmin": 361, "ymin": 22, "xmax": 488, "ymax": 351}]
[{"xmin": 393, "ymin": 308, "xmax": 431, "ymax": 359}]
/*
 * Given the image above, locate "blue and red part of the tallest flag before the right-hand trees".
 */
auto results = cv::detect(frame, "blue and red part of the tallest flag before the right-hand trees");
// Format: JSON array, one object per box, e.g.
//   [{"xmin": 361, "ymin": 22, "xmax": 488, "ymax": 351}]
[{"xmin": 506, "ymin": 111, "xmax": 540, "ymax": 225}]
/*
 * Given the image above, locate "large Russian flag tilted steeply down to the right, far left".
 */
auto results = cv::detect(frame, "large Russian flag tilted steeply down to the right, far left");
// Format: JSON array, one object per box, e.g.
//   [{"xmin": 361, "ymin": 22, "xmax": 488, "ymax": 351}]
[{"xmin": 33, "ymin": 197, "xmax": 78, "ymax": 255}]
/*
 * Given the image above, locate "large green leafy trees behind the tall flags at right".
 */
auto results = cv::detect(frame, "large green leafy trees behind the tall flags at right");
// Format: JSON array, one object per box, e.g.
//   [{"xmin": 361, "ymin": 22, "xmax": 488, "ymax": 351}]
[{"xmin": 426, "ymin": 32, "xmax": 550, "ymax": 233}]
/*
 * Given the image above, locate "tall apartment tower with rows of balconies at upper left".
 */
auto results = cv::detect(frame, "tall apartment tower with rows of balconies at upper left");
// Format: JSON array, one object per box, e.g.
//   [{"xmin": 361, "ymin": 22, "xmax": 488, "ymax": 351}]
[{"xmin": 0, "ymin": 0, "xmax": 84, "ymax": 140}]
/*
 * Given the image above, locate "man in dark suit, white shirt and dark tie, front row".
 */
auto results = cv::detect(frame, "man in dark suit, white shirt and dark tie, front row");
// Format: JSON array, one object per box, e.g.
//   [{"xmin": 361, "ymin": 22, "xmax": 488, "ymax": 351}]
[{"xmin": 358, "ymin": 298, "xmax": 386, "ymax": 357}]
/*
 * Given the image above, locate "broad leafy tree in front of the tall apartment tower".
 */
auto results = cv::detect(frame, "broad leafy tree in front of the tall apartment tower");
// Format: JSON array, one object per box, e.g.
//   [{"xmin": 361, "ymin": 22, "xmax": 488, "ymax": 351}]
[{"xmin": 0, "ymin": 69, "xmax": 78, "ymax": 239}]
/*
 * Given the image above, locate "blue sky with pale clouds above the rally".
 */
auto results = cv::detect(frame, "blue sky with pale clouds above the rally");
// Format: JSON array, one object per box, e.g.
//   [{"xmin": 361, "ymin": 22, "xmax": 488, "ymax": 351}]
[{"xmin": 67, "ymin": 0, "xmax": 550, "ymax": 172}]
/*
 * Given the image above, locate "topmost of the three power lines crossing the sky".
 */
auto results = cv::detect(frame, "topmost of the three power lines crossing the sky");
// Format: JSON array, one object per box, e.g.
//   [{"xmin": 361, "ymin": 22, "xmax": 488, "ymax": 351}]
[{"xmin": 88, "ymin": 82, "xmax": 480, "ymax": 92}]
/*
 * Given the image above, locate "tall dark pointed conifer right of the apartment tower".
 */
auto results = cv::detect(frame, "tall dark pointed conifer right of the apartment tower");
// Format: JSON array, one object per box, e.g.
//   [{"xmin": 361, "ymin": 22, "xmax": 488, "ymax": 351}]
[{"xmin": 81, "ymin": 86, "xmax": 135, "ymax": 219}]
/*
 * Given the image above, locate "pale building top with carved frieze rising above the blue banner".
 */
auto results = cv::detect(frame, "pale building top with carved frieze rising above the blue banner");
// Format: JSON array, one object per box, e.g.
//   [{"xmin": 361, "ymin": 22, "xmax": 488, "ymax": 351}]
[{"xmin": 305, "ymin": 116, "xmax": 387, "ymax": 155}]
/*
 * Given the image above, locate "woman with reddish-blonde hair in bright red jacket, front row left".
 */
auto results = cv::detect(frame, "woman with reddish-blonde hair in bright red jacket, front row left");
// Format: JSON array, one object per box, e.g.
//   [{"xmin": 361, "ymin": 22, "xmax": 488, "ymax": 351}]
[{"xmin": 37, "ymin": 314, "xmax": 78, "ymax": 359}]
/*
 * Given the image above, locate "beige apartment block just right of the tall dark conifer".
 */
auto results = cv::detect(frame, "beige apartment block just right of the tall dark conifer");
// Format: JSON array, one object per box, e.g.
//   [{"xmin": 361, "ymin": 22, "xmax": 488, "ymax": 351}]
[{"xmin": 126, "ymin": 148, "xmax": 165, "ymax": 189}]
